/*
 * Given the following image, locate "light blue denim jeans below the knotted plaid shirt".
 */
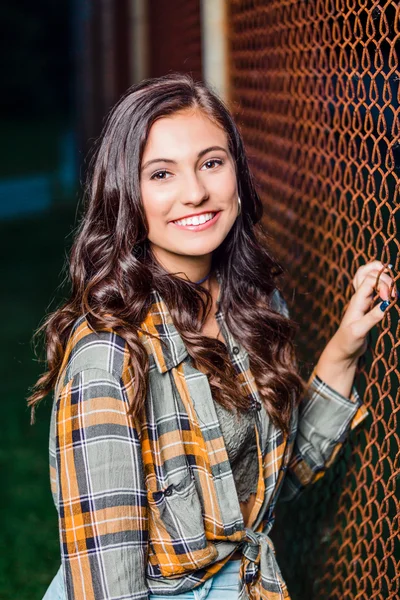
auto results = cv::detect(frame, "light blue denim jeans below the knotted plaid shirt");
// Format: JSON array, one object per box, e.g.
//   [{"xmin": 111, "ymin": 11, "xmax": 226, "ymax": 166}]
[{"xmin": 43, "ymin": 560, "xmax": 240, "ymax": 600}]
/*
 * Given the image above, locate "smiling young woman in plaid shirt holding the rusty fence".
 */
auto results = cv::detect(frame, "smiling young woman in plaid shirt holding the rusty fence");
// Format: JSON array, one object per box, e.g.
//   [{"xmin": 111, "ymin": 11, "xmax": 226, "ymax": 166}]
[{"xmin": 30, "ymin": 75, "xmax": 395, "ymax": 600}]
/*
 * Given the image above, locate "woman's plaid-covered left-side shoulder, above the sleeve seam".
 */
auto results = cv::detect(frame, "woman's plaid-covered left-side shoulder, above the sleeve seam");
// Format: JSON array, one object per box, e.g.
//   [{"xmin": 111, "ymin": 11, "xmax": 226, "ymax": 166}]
[{"xmin": 60, "ymin": 316, "xmax": 129, "ymax": 390}]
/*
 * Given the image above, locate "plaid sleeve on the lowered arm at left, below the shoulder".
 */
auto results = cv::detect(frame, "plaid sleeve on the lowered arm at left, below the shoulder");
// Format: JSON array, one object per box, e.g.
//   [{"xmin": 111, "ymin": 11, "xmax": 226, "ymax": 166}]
[{"xmin": 55, "ymin": 368, "xmax": 149, "ymax": 600}]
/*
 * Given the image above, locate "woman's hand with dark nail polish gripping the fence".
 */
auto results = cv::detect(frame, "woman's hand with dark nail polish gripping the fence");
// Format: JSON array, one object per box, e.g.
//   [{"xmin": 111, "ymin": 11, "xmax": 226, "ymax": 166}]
[{"xmin": 329, "ymin": 260, "xmax": 397, "ymax": 363}]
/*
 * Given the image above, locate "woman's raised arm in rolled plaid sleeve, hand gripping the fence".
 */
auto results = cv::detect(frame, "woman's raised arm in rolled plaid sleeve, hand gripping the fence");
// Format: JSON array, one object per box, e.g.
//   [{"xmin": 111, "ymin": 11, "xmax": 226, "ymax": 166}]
[{"xmin": 281, "ymin": 261, "xmax": 391, "ymax": 500}]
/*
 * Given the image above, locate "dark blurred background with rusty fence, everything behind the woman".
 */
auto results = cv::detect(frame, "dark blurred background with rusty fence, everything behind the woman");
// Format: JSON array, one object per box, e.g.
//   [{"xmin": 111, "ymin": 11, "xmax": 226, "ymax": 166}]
[{"xmin": 0, "ymin": 0, "xmax": 400, "ymax": 600}]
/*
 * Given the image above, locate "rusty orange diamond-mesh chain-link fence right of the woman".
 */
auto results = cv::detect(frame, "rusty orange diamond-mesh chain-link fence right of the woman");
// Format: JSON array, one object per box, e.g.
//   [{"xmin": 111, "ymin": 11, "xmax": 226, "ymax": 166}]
[{"xmin": 228, "ymin": 0, "xmax": 400, "ymax": 600}]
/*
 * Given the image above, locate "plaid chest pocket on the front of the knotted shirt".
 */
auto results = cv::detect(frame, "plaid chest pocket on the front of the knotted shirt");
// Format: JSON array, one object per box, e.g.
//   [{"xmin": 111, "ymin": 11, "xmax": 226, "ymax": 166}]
[{"xmin": 147, "ymin": 472, "xmax": 218, "ymax": 576}]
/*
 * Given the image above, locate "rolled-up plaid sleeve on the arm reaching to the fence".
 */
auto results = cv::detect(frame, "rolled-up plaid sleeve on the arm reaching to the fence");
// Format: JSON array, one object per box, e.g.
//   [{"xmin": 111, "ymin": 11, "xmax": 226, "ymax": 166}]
[{"xmin": 273, "ymin": 292, "xmax": 368, "ymax": 501}]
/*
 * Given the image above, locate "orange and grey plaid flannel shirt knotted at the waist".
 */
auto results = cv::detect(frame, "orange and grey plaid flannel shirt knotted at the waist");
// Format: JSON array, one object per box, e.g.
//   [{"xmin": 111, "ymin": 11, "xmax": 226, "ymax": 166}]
[{"xmin": 50, "ymin": 274, "xmax": 367, "ymax": 600}]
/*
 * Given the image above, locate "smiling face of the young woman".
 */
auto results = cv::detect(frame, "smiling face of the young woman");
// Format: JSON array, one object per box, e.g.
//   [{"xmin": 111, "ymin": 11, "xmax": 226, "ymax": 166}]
[{"xmin": 140, "ymin": 109, "xmax": 238, "ymax": 266}]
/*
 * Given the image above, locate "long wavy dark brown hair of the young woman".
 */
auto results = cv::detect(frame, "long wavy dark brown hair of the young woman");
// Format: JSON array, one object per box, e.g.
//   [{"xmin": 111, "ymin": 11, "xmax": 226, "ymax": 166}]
[{"xmin": 28, "ymin": 74, "xmax": 305, "ymax": 432}]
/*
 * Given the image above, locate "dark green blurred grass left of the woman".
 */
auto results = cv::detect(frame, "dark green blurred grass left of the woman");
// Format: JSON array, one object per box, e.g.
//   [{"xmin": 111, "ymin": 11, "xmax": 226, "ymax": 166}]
[{"xmin": 0, "ymin": 208, "xmax": 75, "ymax": 600}]
